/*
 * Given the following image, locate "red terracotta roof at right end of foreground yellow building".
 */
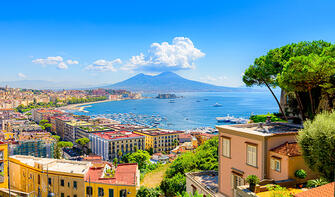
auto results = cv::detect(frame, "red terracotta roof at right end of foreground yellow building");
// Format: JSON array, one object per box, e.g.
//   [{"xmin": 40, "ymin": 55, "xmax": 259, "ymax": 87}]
[{"xmin": 85, "ymin": 163, "xmax": 138, "ymax": 185}]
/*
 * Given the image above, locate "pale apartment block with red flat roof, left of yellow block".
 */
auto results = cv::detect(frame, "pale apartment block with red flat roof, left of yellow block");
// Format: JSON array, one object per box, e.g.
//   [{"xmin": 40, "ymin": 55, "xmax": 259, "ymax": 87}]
[{"xmin": 89, "ymin": 131, "xmax": 145, "ymax": 161}]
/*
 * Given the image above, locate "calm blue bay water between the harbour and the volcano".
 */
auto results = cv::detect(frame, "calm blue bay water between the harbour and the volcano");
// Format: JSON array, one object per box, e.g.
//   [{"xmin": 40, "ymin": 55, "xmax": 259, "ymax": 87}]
[{"xmin": 75, "ymin": 92, "xmax": 278, "ymax": 130}]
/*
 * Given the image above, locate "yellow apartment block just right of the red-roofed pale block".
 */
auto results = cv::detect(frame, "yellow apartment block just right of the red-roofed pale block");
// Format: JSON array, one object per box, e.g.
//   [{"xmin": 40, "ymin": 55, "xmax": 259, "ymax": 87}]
[{"xmin": 134, "ymin": 129, "xmax": 182, "ymax": 153}]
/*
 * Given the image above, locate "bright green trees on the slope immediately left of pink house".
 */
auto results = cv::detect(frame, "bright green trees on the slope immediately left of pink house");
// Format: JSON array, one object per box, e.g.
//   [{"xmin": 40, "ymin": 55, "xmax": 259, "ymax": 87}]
[{"xmin": 161, "ymin": 137, "xmax": 219, "ymax": 196}]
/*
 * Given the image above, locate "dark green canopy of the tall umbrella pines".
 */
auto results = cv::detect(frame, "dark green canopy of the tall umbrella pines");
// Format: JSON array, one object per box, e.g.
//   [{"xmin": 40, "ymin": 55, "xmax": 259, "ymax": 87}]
[{"xmin": 243, "ymin": 40, "xmax": 335, "ymax": 117}]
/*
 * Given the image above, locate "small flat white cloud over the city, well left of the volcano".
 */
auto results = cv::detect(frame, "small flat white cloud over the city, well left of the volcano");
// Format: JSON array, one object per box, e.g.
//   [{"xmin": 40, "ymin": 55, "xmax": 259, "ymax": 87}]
[{"xmin": 32, "ymin": 56, "xmax": 79, "ymax": 70}]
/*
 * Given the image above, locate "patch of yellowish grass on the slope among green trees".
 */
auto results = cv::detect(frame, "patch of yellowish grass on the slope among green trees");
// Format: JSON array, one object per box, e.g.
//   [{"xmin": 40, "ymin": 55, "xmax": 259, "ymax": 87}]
[{"xmin": 141, "ymin": 164, "xmax": 170, "ymax": 188}]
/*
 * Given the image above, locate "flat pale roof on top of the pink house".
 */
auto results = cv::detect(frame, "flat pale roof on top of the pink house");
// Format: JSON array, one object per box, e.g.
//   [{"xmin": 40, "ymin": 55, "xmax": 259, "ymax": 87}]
[{"xmin": 216, "ymin": 123, "xmax": 302, "ymax": 136}]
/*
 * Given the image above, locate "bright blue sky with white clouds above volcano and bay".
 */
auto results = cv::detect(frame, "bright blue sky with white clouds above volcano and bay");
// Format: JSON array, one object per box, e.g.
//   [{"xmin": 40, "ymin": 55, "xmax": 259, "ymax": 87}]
[{"xmin": 0, "ymin": 0, "xmax": 335, "ymax": 87}]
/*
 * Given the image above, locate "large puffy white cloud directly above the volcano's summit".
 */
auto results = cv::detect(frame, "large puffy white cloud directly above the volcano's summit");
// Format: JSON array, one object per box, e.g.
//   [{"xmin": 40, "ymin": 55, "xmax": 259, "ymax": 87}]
[{"xmin": 121, "ymin": 37, "xmax": 205, "ymax": 72}]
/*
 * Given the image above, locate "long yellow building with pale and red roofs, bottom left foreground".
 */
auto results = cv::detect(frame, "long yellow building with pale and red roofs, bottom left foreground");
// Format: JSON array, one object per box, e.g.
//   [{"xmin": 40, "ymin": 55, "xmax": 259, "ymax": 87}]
[{"xmin": 0, "ymin": 155, "xmax": 140, "ymax": 197}]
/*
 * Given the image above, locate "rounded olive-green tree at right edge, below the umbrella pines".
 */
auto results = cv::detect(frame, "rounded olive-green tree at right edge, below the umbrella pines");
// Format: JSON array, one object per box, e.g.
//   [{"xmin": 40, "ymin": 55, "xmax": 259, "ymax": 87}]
[{"xmin": 298, "ymin": 111, "xmax": 335, "ymax": 181}]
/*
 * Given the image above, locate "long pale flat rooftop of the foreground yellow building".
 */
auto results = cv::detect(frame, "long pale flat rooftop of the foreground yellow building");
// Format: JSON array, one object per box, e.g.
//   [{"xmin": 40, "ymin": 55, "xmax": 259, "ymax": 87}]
[{"xmin": 10, "ymin": 155, "xmax": 91, "ymax": 175}]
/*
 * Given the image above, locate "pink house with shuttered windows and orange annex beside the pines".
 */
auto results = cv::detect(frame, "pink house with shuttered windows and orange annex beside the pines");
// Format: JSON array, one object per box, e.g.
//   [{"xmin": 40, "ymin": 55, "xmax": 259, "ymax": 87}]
[{"xmin": 217, "ymin": 123, "xmax": 318, "ymax": 196}]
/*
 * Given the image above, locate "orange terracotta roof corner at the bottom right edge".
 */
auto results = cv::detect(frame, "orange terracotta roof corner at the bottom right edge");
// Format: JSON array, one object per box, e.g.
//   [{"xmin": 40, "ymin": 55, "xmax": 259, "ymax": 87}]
[{"xmin": 295, "ymin": 182, "xmax": 335, "ymax": 197}]
